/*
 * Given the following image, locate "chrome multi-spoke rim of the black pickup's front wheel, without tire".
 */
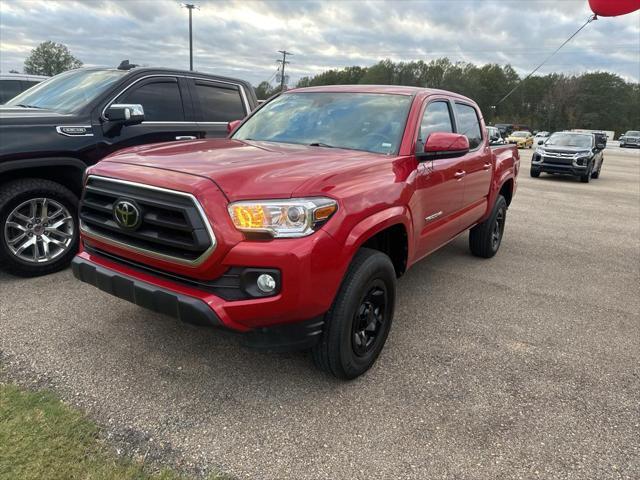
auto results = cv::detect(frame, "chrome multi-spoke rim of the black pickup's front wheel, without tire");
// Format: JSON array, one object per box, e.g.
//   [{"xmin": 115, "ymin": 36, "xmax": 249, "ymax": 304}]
[{"xmin": 4, "ymin": 198, "xmax": 75, "ymax": 264}]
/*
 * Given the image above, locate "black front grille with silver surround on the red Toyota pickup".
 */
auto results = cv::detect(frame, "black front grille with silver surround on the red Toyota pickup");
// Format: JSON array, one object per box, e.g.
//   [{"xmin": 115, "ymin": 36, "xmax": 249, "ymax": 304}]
[{"xmin": 80, "ymin": 176, "xmax": 215, "ymax": 264}]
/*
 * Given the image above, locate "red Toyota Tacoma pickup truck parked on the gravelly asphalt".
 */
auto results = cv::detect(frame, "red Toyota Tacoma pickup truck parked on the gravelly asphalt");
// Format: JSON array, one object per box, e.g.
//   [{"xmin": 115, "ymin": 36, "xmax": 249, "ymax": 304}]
[{"xmin": 72, "ymin": 85, "xmax": 520, "ymax": 378}]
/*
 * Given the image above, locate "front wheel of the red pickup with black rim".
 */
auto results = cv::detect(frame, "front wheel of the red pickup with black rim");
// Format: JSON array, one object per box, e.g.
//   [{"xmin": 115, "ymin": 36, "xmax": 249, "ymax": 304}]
[{"xmin": 312, "ymin": 248, "xmax": 396, "ymax": 380}]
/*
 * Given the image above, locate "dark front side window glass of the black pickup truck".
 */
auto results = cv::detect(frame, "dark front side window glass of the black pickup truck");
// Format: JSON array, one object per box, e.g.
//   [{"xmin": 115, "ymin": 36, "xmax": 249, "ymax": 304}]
[{"xmin": 117, "ymin": 79, "xmax": 184, "ymax": 122}]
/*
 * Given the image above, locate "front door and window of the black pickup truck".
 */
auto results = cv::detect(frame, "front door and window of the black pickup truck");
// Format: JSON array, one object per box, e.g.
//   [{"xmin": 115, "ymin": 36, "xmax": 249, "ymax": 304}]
[{"xmin": 98, "ymin": 75, "xmax": 198, "ymax": 155}]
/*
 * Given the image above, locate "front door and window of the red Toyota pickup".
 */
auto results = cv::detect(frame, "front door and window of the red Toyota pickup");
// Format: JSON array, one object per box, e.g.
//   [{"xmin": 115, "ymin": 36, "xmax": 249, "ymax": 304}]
[{"xmin": 411, "ymin": 97, "xmax": 464, "ymax": 258}]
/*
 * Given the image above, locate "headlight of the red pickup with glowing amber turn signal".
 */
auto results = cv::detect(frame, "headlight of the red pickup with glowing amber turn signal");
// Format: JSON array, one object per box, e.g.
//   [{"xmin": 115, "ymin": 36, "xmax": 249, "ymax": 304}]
[{"xmin": 228, "ymin": 197, "xmax": 338, "ymax": 238}]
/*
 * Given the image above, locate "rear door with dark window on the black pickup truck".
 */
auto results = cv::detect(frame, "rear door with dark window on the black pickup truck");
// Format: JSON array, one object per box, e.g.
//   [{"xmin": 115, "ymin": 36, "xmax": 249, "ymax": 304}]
[{"xmin": 189, "ymin": 78, "xmax": 249, "ymax": 138}]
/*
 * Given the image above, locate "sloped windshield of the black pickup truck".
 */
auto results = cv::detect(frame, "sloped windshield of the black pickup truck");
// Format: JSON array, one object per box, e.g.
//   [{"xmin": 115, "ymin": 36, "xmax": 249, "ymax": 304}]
[{"xmin": 6, "ymin": 69, "xmax": 126, "ymax": 113}]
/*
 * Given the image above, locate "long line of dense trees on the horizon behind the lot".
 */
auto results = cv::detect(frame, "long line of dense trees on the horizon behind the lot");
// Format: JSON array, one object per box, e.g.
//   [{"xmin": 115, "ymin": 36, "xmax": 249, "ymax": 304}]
[{"xmin": 257, "ymin": 58, "xmax": 640, "ymax": 134}]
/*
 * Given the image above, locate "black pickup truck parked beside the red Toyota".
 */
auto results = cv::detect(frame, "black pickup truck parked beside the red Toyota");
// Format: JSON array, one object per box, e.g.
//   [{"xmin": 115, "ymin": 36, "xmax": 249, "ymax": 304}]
[{"xmin": 0, "ymin": 62, "xmax": 258, "ymax": 276}]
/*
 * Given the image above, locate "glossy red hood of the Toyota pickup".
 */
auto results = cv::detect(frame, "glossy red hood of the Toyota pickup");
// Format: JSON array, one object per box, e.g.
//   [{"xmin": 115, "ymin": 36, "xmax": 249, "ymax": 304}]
[{"xmin": 104, "ymin": 139, "xmax": 389, "ymax": 201}]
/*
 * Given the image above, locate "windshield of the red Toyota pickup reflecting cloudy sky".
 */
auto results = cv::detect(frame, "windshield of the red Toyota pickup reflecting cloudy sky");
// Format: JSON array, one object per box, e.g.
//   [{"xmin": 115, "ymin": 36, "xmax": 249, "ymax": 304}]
[{"xmin": 233, "ymin": 92, "xmax": 412, "ymax": 154}]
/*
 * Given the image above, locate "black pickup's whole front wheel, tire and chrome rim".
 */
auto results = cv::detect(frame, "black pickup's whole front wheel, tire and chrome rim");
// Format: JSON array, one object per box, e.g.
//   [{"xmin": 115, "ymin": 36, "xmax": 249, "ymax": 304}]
[{"xmin": 0, "ymin": 178, "xmax": 78, "ymax": 277}]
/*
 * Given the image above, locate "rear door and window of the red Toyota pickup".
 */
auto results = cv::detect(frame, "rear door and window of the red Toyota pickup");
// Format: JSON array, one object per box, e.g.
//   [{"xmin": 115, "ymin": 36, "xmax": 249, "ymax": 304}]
[{"xmin": 454, "ymin": 101, "xmax": 493, "ymax": 228}]
